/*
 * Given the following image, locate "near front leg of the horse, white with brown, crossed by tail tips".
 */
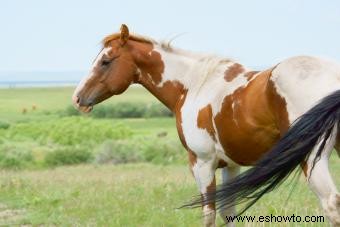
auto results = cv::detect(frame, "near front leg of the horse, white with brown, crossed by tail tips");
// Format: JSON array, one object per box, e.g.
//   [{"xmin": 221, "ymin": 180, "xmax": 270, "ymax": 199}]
[{"xmin": 189, "ymin": 152, "xmax": 216, "ymax": 227}]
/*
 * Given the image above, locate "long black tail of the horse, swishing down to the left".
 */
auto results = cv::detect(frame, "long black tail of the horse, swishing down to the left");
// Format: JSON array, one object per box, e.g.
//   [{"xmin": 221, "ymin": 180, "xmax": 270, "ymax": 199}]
[{"xmin": 186, "ymin": 90, "xmax": 340, "ymax": 214}]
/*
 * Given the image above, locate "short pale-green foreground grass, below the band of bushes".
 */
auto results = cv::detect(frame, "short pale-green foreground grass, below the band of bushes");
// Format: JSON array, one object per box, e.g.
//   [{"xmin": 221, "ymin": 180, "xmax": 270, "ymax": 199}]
[{"xmin": 0, "ymin": 157, "xmax": 340, "ymax": 227}]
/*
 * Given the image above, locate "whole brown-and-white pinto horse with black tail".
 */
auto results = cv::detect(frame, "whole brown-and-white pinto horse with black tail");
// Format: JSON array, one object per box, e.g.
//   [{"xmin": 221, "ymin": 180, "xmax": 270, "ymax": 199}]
[{"xmin": 73, "ymin": 25, "xmax": 340, "ymax": 226}]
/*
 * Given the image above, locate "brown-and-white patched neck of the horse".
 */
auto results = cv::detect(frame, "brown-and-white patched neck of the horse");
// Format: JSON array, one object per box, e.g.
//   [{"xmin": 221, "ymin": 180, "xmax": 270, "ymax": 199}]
[{"xmin": 137, "ymin": 45, "xmax": 198, "ymax": 112}]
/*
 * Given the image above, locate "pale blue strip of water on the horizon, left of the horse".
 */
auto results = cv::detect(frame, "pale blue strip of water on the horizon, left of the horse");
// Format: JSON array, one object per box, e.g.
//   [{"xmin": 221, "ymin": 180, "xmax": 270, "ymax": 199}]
[{"xmin": 0, "ymin": 71, "xmax": 86, "ymax": 88}]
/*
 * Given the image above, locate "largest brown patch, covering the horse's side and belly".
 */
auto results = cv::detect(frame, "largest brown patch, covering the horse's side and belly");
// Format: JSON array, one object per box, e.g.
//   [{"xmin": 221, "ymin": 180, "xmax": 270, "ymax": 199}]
[{"xmin": 214, "ymin": 69, "xmax": 289, "ymax": 165}]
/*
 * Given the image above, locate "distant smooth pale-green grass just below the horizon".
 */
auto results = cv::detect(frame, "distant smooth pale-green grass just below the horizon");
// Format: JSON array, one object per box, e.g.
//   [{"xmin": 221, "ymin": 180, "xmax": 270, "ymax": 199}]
[{"xmin": 0, "ymin": 86, "xmax": 159, "ymax": 122}]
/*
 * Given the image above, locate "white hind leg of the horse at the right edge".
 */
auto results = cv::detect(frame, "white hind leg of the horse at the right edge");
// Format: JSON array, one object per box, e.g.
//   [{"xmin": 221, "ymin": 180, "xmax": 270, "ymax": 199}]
[{"xmin": 303, "ymin": 130, "xmax": 340, "ymax": 226}]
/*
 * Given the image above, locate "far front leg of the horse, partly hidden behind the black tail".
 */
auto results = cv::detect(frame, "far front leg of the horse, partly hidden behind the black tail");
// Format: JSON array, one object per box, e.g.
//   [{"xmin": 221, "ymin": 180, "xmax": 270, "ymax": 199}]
[{"xmin": 219, "ymin": 166, "xmax": 240, "ymax": 227}]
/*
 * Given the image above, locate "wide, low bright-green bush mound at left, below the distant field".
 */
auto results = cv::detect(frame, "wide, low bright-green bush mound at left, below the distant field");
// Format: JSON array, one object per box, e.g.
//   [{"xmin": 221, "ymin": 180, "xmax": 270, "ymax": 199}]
[{"xmin": 5, "ymin": 117, "xmax": 132, "ymax": 145}]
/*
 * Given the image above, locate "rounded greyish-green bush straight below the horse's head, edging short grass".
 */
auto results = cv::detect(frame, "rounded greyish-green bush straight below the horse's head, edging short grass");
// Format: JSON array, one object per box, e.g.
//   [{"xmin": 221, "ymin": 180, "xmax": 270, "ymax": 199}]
[{"xmin": 94, "ymin": 140, "xmax": 142, "ymax": 164}]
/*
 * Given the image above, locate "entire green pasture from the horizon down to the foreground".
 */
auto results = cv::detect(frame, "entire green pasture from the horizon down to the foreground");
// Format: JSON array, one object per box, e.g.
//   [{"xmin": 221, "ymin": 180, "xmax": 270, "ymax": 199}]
[{"xmin": 0, "ymin": 87, "xmax": 340, "ymax": 227}]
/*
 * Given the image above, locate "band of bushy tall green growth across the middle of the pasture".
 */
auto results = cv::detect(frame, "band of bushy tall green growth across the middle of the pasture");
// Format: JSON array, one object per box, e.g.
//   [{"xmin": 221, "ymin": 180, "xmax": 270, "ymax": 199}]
[{"xmin": 0, "ymin": 116, "xmax": 186, "ymax": 169}]
